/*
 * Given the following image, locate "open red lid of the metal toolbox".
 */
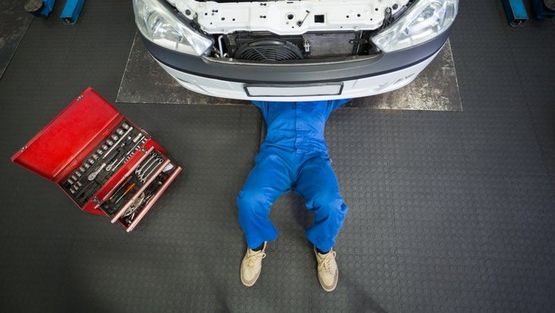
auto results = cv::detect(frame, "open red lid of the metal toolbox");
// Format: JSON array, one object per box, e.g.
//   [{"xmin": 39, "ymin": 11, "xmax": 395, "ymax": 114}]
[{"xmin": 11, "ymin": 87, "xmax": 123, "ymax": 182}]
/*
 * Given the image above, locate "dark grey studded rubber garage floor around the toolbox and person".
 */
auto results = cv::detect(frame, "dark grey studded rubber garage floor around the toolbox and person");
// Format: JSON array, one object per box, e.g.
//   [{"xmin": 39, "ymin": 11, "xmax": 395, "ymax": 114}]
[{"xmin": 0, "ymin": 0, "xmax": 555, "ymax": 313}]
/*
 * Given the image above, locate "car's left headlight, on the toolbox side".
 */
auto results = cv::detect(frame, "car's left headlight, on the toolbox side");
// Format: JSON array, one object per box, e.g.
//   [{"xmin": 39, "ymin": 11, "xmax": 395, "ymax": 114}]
[{"xmin": 133, "ymin": 0, "xmax": 213, "ymax": 56}]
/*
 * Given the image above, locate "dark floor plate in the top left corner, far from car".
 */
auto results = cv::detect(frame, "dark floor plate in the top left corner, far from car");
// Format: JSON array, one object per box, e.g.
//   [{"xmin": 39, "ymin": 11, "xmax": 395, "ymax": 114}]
[{"xmin": 0, "ymin": 0, "xmax": 33, "ymax": 78}]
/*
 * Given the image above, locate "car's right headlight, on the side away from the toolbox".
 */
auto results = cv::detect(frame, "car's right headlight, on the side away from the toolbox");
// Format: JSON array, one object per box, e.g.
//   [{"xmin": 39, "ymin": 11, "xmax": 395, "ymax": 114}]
[{"xmin": 372, "ymin": 0, "xmax": 459, "ymax": 52}]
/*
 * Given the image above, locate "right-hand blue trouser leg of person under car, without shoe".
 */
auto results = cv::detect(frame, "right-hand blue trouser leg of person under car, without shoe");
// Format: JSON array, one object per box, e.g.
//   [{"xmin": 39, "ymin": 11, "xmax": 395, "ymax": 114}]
[{"xmin": 295, "ymin": 157, "xmax": 348, "ymax": 253}]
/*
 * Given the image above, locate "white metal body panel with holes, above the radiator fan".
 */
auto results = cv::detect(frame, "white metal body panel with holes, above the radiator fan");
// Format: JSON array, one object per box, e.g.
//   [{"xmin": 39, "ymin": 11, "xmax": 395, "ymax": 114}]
[{"xmin": 167, "ymin": 0, "xmax": 409, "ymax": 35}]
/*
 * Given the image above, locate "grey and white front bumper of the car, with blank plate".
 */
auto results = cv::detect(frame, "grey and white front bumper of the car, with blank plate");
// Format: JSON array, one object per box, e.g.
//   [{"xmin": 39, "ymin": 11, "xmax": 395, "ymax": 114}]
[{"xmin": 143, "ymin": 31, "xmax": 449, "ymax": 101}]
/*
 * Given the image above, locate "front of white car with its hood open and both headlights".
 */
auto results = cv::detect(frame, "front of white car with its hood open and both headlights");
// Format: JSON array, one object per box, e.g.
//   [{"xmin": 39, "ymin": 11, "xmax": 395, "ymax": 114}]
[{"xmin": 133, "ymin": 0, "xmax": 459, "ymax": 101}]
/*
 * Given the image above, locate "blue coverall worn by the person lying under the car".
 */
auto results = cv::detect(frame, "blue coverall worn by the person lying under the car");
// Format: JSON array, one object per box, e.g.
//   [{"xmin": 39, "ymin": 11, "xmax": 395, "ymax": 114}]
[{"xmin": 237, "ymin": 100, "xmax": 350, "ymax": 252}]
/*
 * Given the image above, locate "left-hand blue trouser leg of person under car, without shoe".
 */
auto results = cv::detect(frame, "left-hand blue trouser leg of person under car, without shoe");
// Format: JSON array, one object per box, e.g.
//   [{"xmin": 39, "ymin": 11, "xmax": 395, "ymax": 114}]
[{"xmin": 237, "ymin": 151, "xmax": 292, "ymax": 249}]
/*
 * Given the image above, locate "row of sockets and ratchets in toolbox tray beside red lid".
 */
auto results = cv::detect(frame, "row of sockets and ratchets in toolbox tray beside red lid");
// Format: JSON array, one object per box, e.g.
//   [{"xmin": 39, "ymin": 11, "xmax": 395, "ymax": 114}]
[{"xmin": 62, "ymin": 120, "xmax": 148, "ymax": 205}]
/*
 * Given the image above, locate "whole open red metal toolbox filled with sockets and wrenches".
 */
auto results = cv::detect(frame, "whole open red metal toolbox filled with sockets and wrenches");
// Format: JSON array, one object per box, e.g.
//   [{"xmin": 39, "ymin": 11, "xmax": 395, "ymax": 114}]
[{"xmin": 12, "ymin": 88, "xmax": 182, "ymax": 232}]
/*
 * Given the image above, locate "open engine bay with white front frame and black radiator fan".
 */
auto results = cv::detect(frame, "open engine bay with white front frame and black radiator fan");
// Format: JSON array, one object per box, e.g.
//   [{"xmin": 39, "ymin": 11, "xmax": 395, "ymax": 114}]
[{"xmin": 167, "ymin": 0, "xmax": 413, "ymax": 63}]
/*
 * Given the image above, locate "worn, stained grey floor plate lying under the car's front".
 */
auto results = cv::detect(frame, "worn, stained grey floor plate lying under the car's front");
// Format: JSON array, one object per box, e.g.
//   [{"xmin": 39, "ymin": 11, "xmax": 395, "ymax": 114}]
[{"xmin": 116, "ymin": 34, "xmax": 462, "ymax": 111}]
